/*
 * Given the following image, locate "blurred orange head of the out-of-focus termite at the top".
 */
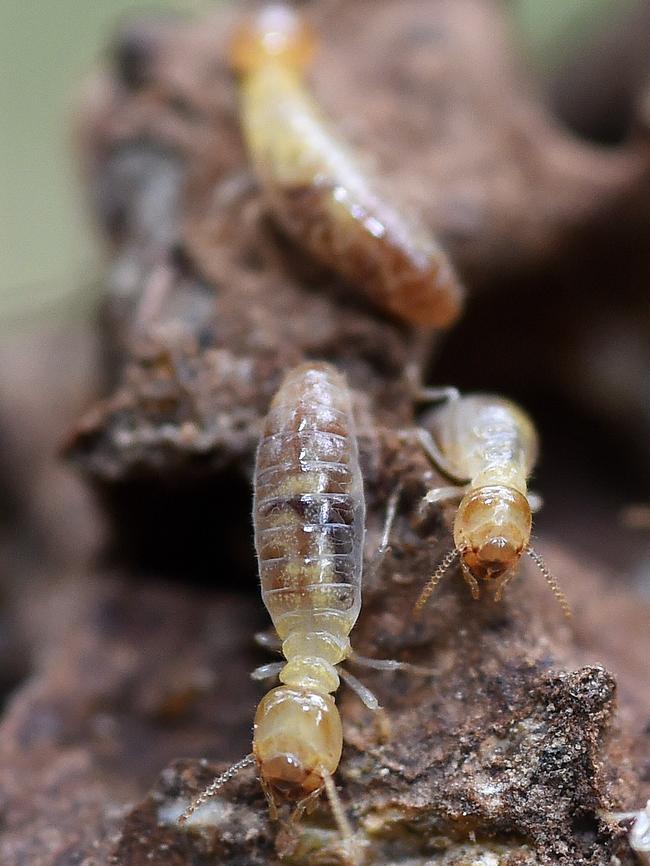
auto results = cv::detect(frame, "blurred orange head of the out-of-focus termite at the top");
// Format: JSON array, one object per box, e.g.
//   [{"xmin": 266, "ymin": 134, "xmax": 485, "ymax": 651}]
[{"xmin": 230, "ymin": 4, "xmax": 316, "ymax": 73}]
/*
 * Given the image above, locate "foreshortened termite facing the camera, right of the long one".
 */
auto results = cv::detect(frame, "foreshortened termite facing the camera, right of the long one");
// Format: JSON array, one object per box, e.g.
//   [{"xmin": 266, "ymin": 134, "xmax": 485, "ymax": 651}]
[{"xmin": 415, "ymin": 389, "xmax": 571, "ymax": 617}]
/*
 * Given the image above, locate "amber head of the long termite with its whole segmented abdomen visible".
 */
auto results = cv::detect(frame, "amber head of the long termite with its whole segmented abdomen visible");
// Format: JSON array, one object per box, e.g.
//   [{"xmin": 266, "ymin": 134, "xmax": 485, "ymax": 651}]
[{"xmin": 253, "ymin": 686, "xmax": 343, "ymax": 806}]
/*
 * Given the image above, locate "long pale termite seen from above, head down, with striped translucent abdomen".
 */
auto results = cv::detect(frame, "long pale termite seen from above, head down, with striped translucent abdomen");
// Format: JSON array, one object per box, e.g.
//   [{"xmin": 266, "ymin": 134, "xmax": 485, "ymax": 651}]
[{"xmin": 180, "ymin": 363, "xmax": 418, "ymax": 842}]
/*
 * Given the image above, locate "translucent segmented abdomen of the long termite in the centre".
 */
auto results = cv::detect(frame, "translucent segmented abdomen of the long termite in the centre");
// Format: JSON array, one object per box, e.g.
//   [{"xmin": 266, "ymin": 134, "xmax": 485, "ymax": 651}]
[{"xmin": 253, "ymin": 363, "xmax": 365, "ymax": 639}]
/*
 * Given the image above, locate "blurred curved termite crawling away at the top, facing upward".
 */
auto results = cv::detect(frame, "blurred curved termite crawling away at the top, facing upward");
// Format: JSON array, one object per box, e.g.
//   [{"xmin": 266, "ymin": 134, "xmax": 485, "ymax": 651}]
[{"xmin": 230, "ymin": 6, "xmax": 463, "ymax": 327}]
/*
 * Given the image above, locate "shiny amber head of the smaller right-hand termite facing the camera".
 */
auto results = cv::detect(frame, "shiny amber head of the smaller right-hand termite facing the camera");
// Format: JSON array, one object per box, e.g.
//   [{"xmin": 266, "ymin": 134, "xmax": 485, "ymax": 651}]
[{"xmin": 454, "ymin": 485, "xmax": 532, "ymax": 581}]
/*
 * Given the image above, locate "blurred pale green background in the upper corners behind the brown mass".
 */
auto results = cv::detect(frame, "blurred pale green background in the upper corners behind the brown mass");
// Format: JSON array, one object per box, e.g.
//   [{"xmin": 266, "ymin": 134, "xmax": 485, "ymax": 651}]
[{"xmin": 0, "ymin": 0, "xmax": 628, "ymax": 330}]
